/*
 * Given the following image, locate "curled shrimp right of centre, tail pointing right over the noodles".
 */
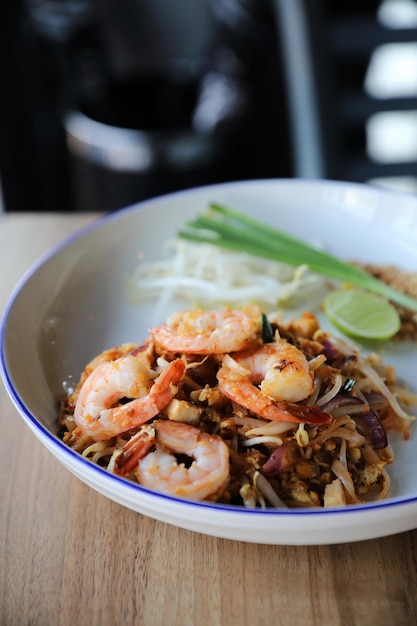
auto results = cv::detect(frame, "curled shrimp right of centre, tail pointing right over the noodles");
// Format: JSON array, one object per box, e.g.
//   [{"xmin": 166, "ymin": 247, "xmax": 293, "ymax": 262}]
[{"xmin": 217, "ymin": 340, "xmax": 331, "ymax": 424}]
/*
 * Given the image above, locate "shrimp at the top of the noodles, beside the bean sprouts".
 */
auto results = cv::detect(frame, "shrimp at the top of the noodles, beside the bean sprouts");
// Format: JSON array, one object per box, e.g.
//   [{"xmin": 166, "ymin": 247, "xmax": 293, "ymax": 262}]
[{"xmin": 149, "ymin": 305, "xmax": 261, "ymax": 354}]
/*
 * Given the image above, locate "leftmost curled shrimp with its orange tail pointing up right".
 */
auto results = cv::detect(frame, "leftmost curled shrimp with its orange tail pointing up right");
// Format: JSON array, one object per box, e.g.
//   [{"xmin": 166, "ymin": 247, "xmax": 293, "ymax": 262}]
[{"xmin": 74, "ymin": 353, "xmax": 185, "ymax": 441}]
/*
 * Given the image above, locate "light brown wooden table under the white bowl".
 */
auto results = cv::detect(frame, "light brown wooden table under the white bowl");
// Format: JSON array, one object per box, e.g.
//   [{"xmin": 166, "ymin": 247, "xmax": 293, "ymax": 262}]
[{"xmin": 0, "ymin": 214, "xmax": 417, "ymax": 626}]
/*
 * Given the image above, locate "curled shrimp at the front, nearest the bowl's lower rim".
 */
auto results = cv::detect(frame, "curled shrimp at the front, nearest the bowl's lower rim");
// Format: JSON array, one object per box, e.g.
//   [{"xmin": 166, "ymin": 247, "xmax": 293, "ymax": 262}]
[{"xmin": 136, "ymin": 420, "xmax": 229, "ymax": 500}]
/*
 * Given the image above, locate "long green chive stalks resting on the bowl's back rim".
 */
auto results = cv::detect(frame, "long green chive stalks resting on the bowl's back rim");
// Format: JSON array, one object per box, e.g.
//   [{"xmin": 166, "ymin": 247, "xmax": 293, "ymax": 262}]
[{"xmin": 178, "ymin": 204, "xmax": 417, "ymax": 311}]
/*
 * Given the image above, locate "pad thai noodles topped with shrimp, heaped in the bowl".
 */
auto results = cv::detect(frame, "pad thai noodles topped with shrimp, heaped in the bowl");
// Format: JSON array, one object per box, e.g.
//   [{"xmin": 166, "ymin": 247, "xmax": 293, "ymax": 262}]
[{"xmin": 59, "ymin": 305, "xmax": 417, "ymax": 507}]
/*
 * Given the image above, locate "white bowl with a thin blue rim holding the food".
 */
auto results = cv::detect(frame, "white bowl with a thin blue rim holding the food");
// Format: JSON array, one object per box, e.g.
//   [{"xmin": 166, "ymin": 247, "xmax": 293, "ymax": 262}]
[{"xmin": 1, "ymin": 180, "xmax": 417, "ymax": 545}]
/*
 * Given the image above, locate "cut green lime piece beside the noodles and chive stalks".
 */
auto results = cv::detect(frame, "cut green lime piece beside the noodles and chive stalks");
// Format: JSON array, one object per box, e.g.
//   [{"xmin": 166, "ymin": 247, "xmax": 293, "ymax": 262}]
[{"xmin": 323, "ymin": 289, "xmax": 401, "ymax": 341}]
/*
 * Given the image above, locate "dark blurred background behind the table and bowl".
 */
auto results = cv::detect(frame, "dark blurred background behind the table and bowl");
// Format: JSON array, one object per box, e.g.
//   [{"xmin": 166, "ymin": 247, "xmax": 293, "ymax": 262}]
[{"xmin": 0, "ymin": 0, "xmax": 417, "ymax": 212}]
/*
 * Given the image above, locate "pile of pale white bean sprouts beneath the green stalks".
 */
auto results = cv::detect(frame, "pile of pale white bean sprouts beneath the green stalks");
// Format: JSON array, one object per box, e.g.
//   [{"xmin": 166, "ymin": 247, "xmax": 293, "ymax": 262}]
[{"xmin": 130, "ymin": 239, "xmax": 326, "ymax": 315}]
